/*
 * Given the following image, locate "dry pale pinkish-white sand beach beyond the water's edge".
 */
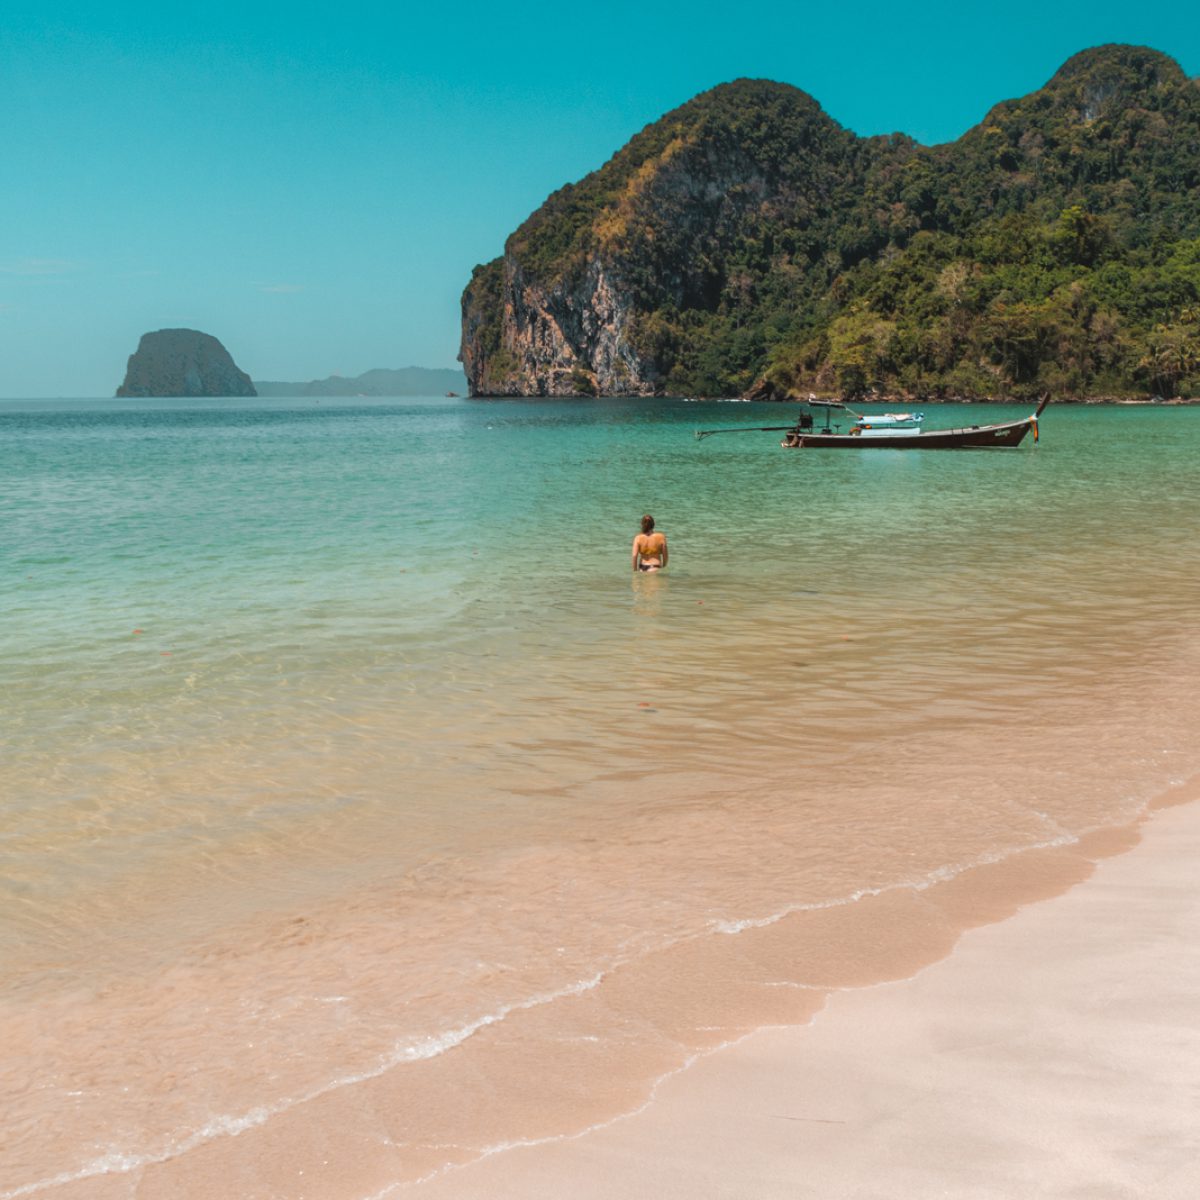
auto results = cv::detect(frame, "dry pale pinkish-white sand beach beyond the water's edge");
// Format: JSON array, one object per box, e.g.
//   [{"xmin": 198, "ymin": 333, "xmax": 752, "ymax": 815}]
[{"xmin": 415, "ymin": 784, "xmax": 1200, "ymax": 1200}]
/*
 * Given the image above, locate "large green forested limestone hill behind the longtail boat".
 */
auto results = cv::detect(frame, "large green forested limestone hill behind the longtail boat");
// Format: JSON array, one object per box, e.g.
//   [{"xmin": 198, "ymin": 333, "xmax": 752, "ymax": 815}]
[{"xmin": 462, "ymin": 46, "xmax": 1200, "ymax": 398}]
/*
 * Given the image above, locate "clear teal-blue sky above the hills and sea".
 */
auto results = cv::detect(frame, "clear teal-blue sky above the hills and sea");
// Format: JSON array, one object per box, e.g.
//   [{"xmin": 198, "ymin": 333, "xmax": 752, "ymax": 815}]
[{"xmin": 0, "ymin": 0, "xmax": 1200, "ymax": 397}]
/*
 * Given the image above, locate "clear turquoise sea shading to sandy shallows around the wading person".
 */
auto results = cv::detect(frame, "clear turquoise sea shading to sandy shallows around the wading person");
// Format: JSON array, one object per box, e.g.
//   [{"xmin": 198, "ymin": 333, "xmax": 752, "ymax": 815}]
[{"xmin": 0, "ymin": 397, "xmax": 1200, "ymax": 1200}]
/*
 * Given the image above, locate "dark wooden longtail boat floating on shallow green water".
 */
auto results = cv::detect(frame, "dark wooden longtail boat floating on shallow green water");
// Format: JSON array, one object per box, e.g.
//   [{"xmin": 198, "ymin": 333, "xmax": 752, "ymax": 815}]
[{"xmin": 696, "ymin": 396, "xmax": 1050, "ymax": 450}]
